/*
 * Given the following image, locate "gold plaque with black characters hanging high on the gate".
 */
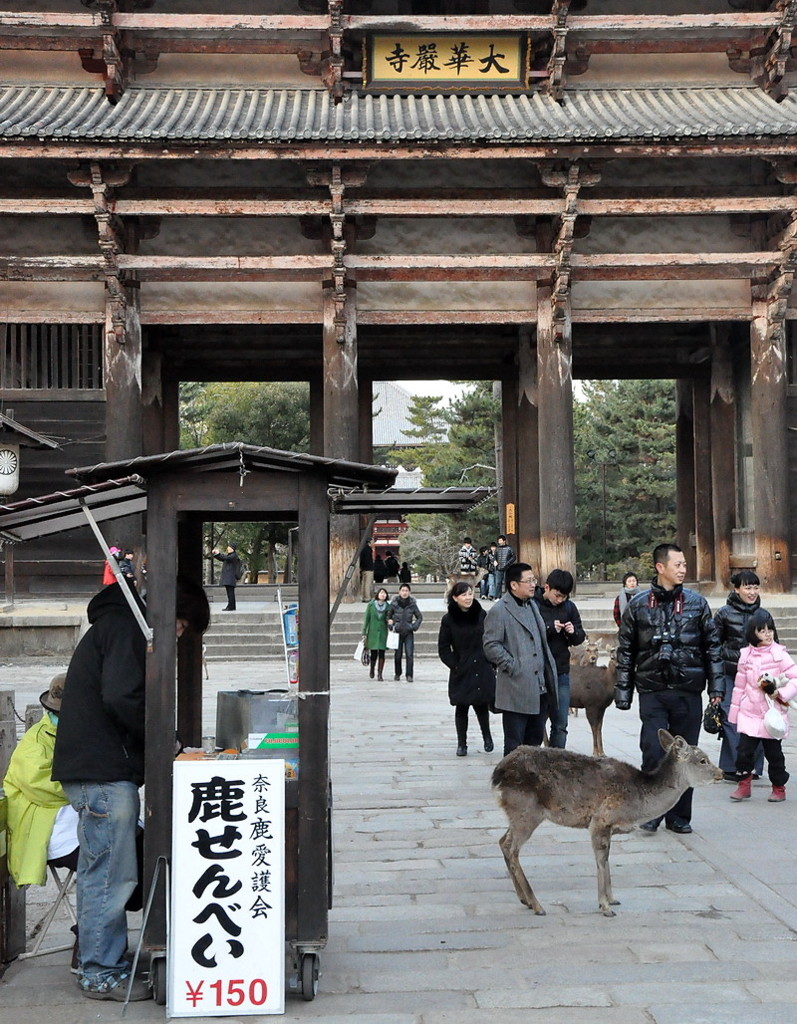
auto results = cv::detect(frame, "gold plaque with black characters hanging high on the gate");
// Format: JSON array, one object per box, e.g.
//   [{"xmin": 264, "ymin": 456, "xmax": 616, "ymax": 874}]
[{"xmin": 365, "ymin": 33, "xmax": 528, "ymax": 91}]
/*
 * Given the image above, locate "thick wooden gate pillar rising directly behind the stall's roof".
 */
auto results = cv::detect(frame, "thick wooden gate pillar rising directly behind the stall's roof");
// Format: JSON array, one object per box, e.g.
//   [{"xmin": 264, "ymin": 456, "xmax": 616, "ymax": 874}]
[{"xmin": 324, "ymin": 283, "xmax": 360, "ymax": 601}]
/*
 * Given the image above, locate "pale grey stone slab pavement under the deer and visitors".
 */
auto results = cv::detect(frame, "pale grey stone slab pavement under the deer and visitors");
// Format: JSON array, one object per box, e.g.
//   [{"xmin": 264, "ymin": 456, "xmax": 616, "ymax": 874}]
[{"xmin": 0, "ymin": 662, "xmax": 797, "ymax": 1024}]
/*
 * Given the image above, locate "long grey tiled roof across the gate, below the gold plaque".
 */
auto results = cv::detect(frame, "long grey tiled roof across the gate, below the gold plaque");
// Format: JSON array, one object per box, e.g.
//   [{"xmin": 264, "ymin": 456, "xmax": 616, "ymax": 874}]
[{"xmin": 0, "ymin": 85, "xmax": 797, "ymax": 144}]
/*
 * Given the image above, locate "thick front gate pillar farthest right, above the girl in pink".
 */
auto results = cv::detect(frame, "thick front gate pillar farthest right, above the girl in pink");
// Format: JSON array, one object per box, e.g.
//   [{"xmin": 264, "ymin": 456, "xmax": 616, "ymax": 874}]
[{"xmin": 750, "ymin": 287, "xmax": 792, "ymax": 594}]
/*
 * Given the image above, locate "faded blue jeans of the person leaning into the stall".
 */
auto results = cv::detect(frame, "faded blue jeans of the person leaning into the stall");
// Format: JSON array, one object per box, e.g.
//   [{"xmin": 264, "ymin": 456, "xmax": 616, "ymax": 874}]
[{"xmin": 62, "ymin": 782, "xmax": 139, "ymax": 988}]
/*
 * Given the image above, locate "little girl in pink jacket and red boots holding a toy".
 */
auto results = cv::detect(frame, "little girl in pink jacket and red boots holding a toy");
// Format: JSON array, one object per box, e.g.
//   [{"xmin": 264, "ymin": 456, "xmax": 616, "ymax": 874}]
[{"xmin": 728, "ymin": 608, "xmax": 797, "ymax": 804}]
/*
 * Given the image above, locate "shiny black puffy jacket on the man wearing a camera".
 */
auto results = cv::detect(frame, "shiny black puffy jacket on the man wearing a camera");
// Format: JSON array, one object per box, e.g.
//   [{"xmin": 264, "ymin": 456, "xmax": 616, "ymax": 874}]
[{"xmin": 615, "ymin": 583, "xmax": 725, "ymax": 708}]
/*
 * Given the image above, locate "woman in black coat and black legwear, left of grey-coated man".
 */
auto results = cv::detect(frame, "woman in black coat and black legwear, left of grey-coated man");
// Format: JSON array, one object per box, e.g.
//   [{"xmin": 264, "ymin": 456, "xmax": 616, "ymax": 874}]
[{"xmin": 437, "ymin": 581, "xmax": 496, "ymax": 758}]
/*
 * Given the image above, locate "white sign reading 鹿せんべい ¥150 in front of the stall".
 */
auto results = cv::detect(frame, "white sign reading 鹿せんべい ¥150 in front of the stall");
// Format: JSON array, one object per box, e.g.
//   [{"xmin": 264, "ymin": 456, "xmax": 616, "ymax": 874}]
[{"xmin": 167, "ymin": 759, "xmax": 285, "ymax": 1017}]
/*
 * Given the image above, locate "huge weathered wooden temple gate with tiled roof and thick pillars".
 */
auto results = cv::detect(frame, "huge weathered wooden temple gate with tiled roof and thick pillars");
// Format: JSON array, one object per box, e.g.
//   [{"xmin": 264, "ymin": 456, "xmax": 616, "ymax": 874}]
[{"xmin": 0, "ymin": 0, "xmax": 797, "ymax": 592}]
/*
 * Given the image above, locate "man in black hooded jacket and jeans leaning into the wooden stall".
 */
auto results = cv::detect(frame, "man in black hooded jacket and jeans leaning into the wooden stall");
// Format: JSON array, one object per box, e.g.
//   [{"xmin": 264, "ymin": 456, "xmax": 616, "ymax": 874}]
[{"xmin": 52, "ymin": 580, "xmax": 210, "ymax": 1001}]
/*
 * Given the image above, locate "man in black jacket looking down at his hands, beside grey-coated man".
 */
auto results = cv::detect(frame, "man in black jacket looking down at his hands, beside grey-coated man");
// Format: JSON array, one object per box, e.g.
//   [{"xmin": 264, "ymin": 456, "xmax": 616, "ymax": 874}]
[{"xmin": 534, "ymin": 569, "xmax": 587, "ymax": 749}]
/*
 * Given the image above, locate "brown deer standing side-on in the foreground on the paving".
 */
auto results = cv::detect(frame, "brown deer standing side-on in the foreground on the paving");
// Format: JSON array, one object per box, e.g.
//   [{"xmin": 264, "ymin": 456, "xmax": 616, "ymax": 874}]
[{"xmin": 493, "ymin": 729, "xmax": 722, "ymax": 918}]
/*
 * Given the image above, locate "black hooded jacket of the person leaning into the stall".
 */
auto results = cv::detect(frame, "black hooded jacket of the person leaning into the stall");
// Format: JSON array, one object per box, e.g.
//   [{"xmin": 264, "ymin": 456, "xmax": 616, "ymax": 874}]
[{"xmin": 52, "ymin": 583, "xmax": 146, "ymax": 785}]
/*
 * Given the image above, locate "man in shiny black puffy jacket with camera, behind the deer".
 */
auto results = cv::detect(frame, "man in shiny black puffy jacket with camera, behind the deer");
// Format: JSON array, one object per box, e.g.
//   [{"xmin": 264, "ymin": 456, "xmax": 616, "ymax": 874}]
[{"xmin": 615, "ymin": 544, "xmax": 724, "ymax": 834}]
